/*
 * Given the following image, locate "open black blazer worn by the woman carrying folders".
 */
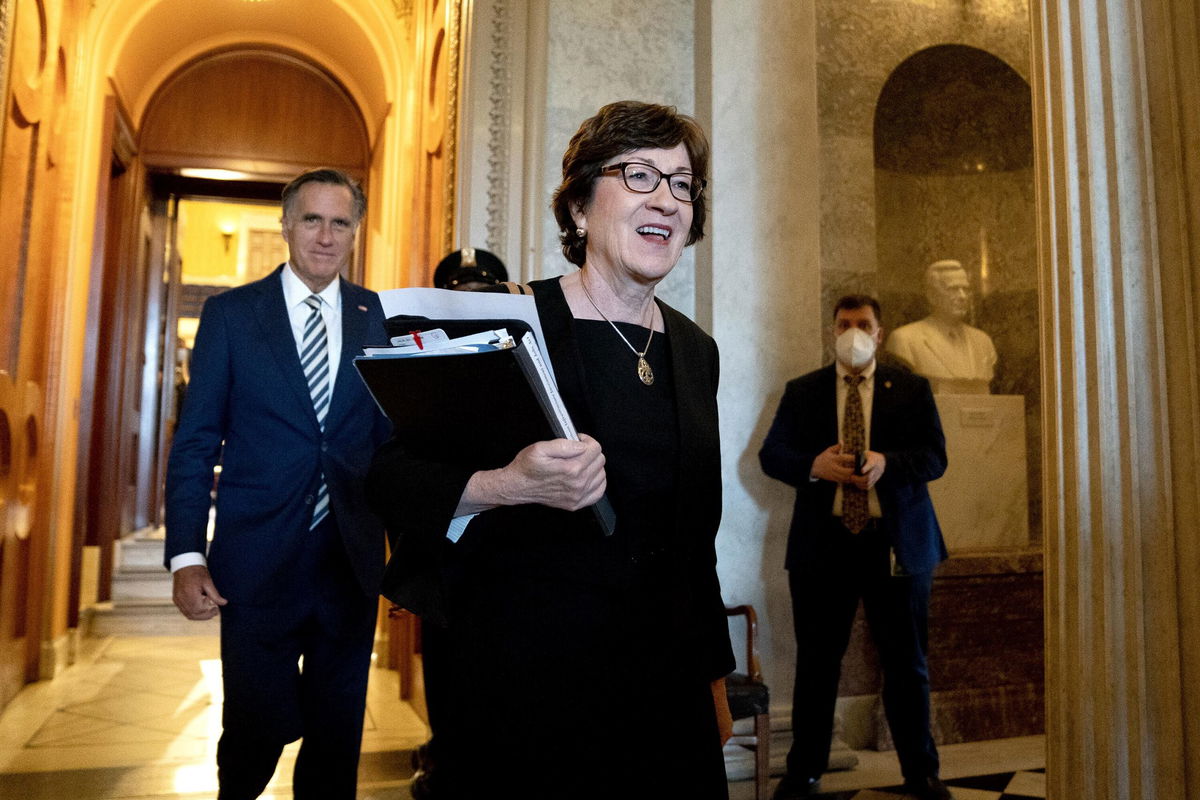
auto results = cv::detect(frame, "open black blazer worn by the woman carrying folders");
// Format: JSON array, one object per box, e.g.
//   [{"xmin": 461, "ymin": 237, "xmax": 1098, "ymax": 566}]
[{"xmin": 368, "ymin": 278, "xmax": 733, "ymax": 680}]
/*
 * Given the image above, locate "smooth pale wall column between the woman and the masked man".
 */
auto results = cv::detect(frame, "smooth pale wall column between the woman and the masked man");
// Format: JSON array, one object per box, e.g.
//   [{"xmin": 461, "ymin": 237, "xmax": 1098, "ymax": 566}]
[{"xmin": 697, "ymin": 0, "xmax": 829, "ymax": 734}]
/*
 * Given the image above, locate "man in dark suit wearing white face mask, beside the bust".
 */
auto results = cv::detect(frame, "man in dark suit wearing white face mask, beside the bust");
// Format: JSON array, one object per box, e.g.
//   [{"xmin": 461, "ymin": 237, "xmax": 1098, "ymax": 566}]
[{"xmin": 758, "ymin": 295, "xmax": 950, "ymax": 800}]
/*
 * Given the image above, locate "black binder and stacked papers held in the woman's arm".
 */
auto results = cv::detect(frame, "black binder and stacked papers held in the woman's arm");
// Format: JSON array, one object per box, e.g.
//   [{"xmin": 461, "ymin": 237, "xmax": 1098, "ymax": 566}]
[{"xmin": 354, "ymin": 319, "xmax": 616, "ymax": 534}]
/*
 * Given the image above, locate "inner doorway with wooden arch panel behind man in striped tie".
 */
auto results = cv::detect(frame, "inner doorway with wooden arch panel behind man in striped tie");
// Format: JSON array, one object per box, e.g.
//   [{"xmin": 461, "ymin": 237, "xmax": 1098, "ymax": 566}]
[{"xmin": 77, "ymin": 48, "xmax": 371, "ymax": 600}]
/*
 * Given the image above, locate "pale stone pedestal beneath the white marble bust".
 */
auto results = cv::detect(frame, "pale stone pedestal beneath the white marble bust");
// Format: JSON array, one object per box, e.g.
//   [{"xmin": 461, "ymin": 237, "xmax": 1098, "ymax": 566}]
[{"xmin": 929, "ymin": 395, "xmax": 1030, "ymax": 555}]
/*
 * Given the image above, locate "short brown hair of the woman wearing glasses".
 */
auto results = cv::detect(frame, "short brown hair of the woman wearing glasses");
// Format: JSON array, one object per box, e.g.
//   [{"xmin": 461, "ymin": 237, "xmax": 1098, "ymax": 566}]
[{"xmin": 551, "ymin": 100, "xmax": 708, "ymax": 266}]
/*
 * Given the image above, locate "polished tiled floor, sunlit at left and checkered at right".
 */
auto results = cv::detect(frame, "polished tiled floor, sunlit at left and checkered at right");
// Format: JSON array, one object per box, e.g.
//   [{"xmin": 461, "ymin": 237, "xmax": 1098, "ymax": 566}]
[{"xmin": 0, "ymin": 622, "xmax": 1045, "ymax": 800}]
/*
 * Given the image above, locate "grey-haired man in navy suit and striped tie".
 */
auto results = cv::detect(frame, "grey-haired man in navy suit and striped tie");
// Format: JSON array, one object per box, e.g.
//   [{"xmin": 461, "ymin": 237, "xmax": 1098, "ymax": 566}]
[{"xmin": 164, "ymin": 169, "xmax": 388, "ymax": 800}]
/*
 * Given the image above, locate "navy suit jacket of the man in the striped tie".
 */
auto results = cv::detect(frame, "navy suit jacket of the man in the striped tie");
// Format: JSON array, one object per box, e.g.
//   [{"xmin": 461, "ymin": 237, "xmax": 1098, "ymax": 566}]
[{"xmin": 164, "ymin": 265, "xmax": 390, "ymax": 604}]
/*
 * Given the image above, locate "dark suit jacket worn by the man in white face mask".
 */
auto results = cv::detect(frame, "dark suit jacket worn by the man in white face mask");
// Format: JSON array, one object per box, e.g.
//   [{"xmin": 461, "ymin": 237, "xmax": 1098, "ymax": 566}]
[{"xmin": 758, "ymin": 365, "xmax": 947, "ymax": 575}]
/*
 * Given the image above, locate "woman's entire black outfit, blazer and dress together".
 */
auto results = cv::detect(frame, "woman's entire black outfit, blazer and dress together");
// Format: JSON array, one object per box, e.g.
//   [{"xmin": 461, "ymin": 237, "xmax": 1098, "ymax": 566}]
[{"xmin": 371, "ymin": 281, "xmax": 733, "ymax": 800}]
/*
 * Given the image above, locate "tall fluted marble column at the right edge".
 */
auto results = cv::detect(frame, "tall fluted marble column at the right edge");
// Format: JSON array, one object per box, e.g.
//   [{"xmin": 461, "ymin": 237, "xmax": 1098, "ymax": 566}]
[{"xmin": 1033, "ymin": 0, "xmax": 1200, "ymax": 800}]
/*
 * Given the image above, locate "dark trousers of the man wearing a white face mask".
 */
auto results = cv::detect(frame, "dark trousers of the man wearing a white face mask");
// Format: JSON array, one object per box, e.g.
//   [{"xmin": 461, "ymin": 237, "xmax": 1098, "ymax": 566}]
[{"xmin": 787, "ymin": 517, "xmax": 938, "ymax": 780}]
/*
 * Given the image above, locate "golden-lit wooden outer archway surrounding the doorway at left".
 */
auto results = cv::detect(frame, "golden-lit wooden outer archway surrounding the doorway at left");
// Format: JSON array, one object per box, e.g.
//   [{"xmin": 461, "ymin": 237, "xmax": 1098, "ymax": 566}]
[{"xmin": 0, "ymin": 0, "xmax": 464, "ymax": 703}]
